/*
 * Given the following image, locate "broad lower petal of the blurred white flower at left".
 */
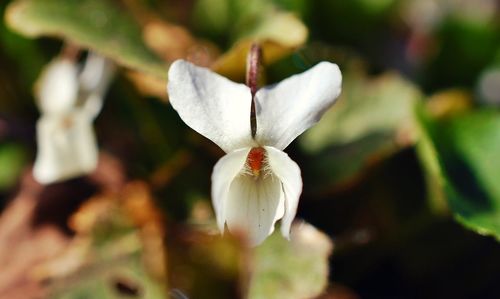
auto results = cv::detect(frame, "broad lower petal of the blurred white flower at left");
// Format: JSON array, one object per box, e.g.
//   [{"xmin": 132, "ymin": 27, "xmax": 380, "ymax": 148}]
[{"xmin": 33, "ymin": 111, "xmax": 98, "ymax": 184}]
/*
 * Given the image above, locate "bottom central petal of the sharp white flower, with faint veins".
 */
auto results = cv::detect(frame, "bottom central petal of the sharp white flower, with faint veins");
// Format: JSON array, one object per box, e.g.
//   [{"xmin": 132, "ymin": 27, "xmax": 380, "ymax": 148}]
[{"xmin": 225, "ymin": 174, "xmax": 284, "ymax": 246}]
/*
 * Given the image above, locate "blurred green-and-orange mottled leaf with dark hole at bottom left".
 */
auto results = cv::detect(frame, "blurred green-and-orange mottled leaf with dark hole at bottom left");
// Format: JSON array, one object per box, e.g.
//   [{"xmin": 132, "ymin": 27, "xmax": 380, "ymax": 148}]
[{"xmin": 45, "ymin": 195, "xmax": 167, "ymax": 299}]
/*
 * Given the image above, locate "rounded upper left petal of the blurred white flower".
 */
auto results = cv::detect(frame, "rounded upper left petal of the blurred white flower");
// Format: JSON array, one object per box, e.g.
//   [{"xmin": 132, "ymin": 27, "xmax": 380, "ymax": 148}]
[{"xmin": 36, "ymin": 59, "xmax": 78, "ymax": 114}]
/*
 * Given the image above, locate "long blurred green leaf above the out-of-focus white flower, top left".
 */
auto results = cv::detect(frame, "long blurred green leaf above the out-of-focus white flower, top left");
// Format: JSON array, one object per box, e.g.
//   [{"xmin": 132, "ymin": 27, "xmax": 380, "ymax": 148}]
[{"xmin": 6, "ymin": 0, "xmax": 167, "ymax": 79}]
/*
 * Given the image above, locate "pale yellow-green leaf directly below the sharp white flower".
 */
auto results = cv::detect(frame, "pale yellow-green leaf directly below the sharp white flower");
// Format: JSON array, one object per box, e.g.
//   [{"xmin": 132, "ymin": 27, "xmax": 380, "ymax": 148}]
[{"xmin": 248, "ymin": 223, "xmax": 332, "ymax": 299}]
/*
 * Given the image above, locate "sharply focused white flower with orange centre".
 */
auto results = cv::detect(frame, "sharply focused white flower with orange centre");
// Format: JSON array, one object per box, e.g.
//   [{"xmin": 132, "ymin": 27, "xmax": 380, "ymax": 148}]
[{"xmin": 167, "ymin": 60, "xmax": 342, "ymax": 245}]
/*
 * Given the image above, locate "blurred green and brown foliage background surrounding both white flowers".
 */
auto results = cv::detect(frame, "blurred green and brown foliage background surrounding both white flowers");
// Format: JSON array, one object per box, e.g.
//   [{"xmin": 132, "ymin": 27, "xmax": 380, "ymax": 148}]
[{"xmin": 0, "ymin": 0, "xmax": 500, "ymax": 299}]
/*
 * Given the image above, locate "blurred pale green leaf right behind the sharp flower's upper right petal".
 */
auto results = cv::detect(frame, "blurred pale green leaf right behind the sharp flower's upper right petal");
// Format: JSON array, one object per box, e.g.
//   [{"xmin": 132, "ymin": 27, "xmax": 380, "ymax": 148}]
[{"xmin": 299, "ymin": 69, "xmax": 422, "ymax": 192}]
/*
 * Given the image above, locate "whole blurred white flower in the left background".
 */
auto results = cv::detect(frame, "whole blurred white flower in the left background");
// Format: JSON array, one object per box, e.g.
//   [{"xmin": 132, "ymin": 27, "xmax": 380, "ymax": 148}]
[{"xmin": 33, "ymin": 53, "xmax": 114, "ymax": 184}]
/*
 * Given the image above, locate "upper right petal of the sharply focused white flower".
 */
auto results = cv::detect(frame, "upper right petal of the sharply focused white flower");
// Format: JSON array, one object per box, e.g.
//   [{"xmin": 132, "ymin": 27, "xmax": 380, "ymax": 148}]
[{"xmin": 255, "ymin": 62, "xmax": 342, "ymax": 150}]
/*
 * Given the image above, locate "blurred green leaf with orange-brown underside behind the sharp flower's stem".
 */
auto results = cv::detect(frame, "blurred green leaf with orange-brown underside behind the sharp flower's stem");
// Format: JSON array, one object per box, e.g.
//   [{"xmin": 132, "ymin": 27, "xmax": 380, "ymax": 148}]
[{"xmin": 195, "ymin": 0, "xmax": 308, "ymax": 81}]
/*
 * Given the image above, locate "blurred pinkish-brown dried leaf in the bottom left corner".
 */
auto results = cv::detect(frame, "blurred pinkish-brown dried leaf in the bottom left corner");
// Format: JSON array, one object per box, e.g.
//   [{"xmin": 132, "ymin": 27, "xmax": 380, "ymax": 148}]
[{"xmin": 0, "ymin": 175, "xmax": 69, "ymax": 299}]
